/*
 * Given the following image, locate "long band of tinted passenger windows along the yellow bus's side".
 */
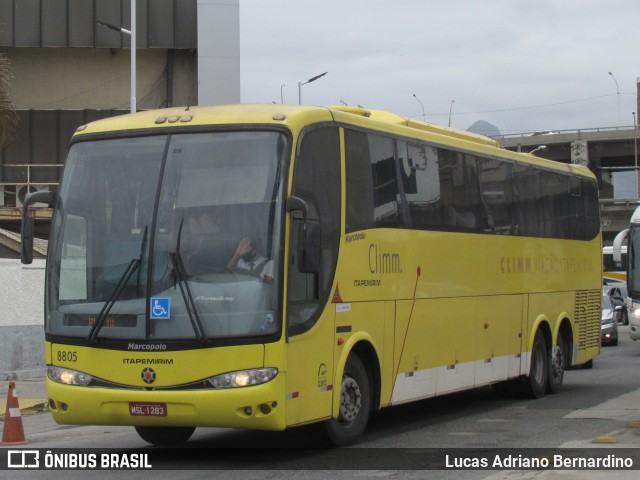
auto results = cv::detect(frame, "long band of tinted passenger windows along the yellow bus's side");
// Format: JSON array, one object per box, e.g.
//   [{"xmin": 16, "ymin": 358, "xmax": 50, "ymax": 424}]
[{"xmin": 345, "ymin": 130, "xmax": 600, "ymax": 240}]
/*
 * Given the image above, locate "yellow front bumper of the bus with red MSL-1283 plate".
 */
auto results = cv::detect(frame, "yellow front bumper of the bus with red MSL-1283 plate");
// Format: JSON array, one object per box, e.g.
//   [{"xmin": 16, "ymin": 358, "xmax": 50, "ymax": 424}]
[{"xmin": 47, "ymin": 372, "xmax": 285, "ymax": 430}]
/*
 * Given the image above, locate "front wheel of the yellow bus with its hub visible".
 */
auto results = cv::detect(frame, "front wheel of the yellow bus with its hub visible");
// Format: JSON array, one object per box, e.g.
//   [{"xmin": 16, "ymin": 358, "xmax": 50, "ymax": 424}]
[{"xmin": 323, "ymin": 355, "xmax": 371, "ymax": 447}]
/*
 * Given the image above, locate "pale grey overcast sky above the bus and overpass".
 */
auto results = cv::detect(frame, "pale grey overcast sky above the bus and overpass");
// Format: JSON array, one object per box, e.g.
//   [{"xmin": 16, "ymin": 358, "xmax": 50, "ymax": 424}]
[{"xmin": 240, "ymin": 0, "xmax": 640, "ymax": 134}]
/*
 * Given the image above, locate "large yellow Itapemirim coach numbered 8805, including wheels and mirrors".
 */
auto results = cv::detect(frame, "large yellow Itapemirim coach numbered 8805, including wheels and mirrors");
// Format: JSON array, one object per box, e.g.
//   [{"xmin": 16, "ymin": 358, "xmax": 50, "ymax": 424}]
[{"xmin": 23, "ymin": 105, "xmax": 602, "ymax": 445}]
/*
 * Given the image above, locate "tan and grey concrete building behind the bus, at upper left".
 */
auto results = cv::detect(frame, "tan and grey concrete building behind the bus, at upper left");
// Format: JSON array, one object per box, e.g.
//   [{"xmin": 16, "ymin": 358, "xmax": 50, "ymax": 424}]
[{"xmin": 0, "ymin": 0, "xmax": 240, "ymax": 230}]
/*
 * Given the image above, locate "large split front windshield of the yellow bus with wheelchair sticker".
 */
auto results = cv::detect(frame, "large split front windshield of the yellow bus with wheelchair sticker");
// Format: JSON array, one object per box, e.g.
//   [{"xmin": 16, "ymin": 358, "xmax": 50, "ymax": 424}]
[{"xmin": 45, "ymin": 131, "xmax": 288, "ymax": 343}]
